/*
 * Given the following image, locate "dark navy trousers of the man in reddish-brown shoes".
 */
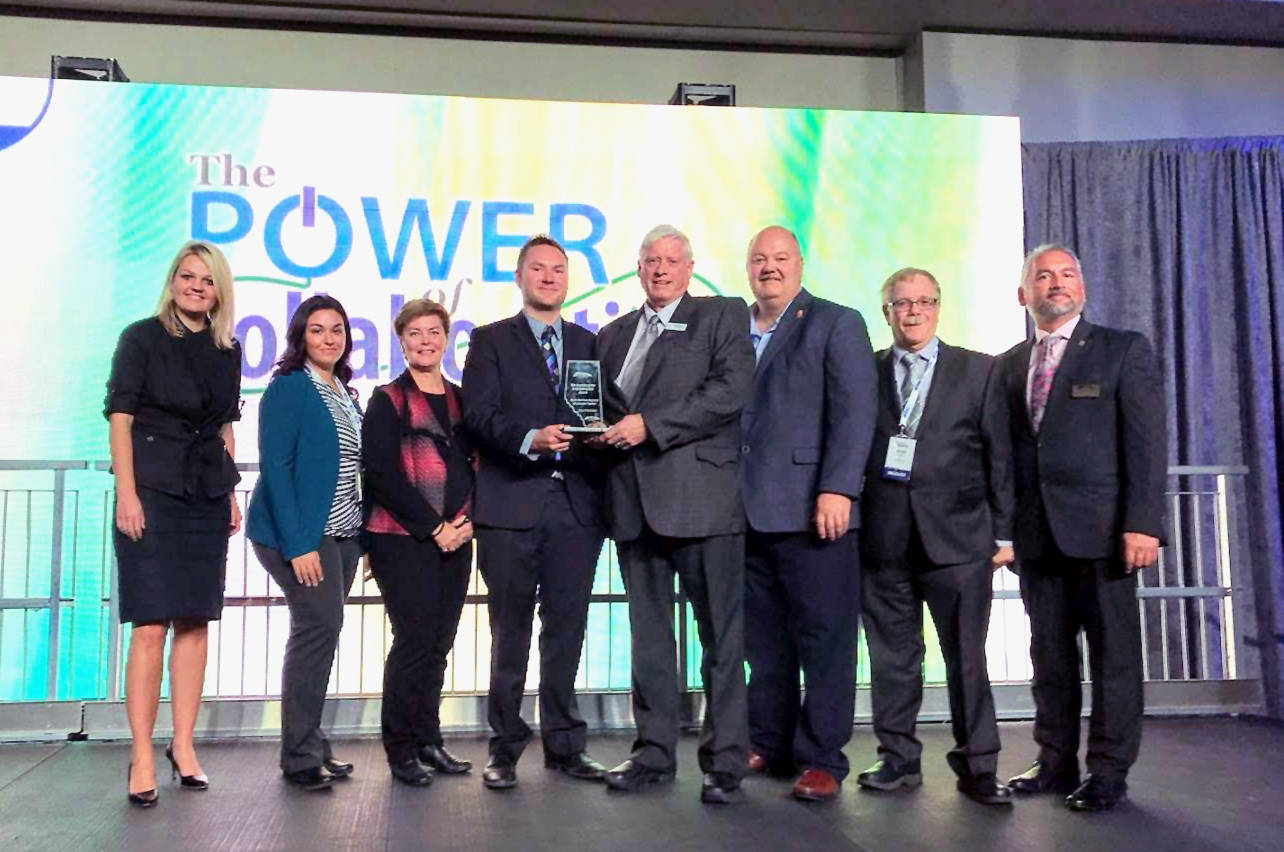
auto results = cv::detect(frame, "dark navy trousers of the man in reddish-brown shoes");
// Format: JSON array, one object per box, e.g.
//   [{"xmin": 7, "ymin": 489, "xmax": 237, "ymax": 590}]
[{"xmin": 745, "ymin": 531, "xmax": 860, "ymax": 780}]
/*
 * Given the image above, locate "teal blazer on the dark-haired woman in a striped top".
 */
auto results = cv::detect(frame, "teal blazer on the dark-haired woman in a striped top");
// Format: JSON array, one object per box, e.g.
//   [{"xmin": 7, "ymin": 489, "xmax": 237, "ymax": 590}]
[{"xmin": 245, "ymin": 370, "xmax": 339, "ymax": 559}]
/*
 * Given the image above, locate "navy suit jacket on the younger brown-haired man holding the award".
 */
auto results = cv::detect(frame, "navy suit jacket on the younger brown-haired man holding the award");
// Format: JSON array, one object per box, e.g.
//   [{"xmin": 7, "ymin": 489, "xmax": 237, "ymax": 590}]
[{"xmin": 462, "ymin": 313, "xmax": 602, "ymax": 530}]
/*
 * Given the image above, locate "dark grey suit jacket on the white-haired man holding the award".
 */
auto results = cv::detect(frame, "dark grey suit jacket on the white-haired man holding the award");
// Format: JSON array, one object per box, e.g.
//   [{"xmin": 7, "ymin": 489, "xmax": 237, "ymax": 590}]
[{"xmin": 597, "ymin": 294, "xmax": 754, "ymax": 541}]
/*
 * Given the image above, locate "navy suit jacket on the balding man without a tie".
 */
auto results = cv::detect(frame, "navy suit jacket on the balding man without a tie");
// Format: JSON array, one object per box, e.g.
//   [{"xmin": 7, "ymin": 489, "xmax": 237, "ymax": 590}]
[{"xmin": 740, "ymin": 290, "xmax": 878, "ymax": 533}]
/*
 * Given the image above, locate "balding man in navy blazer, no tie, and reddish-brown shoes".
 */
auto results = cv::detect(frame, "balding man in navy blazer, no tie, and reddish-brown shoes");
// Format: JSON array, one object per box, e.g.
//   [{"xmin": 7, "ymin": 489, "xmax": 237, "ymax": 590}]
[{"xmin": 740, "ymin": 226, "xmax": 878, "ymax": 801}]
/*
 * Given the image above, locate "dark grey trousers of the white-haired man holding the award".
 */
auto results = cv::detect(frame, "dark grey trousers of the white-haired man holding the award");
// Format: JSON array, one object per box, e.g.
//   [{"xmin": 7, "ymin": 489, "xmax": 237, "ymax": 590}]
[{"xmin": 616, "ymin": 527, "xmax": 749, "ymax": 779}]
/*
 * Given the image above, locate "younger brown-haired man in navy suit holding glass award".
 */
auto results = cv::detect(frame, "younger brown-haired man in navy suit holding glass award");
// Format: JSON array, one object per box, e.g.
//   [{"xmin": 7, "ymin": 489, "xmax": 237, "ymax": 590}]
[{"xmin": 462, "ymin": 235, "xmax": 605, "ymax": 789}]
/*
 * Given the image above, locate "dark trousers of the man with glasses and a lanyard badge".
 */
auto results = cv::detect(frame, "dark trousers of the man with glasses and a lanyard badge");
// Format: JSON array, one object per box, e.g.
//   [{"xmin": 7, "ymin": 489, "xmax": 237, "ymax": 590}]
[{"xmin": 863, "ymin": 530, "xmax": 999, "ymax": 778}]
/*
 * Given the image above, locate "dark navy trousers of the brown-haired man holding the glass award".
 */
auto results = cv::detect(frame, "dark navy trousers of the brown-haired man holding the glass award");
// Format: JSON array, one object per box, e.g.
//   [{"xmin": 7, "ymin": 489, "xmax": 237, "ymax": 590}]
[{"xmin": 478, "ymin": 477, "xmax": 605, "ymax": 763}]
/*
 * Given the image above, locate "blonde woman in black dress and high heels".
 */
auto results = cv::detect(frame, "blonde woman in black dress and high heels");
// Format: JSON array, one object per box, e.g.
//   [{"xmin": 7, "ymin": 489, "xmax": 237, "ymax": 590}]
[{"xmin": 105, "ymin": 243, "xmax": 240, "ymax": 807}]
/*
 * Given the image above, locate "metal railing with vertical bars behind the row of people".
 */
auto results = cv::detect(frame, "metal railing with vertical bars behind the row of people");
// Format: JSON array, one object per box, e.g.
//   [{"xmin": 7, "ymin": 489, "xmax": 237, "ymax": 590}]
[{"xmin": 0, "ymin": 461, "xmax": 1251, "ymax": 702}]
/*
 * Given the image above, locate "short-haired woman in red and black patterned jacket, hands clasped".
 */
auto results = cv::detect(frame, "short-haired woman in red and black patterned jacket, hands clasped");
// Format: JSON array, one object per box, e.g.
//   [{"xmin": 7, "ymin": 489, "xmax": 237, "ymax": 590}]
[{"xmin": 361, "ymin": 299, "xmax": 474, "ymax": 787}]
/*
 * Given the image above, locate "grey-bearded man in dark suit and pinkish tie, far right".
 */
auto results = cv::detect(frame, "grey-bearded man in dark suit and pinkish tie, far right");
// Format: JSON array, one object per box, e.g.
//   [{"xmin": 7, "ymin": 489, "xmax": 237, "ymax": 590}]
[{"xmin": 999, "ymin": 244, "xmax": 1167, "ymax": 811}]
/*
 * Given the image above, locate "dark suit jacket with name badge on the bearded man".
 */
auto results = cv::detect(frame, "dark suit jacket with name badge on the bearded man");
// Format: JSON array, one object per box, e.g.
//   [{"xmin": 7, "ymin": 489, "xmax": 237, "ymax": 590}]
[{"xmin": 999, "ymin": 320, "xmax": 1168, "ymax": 561}]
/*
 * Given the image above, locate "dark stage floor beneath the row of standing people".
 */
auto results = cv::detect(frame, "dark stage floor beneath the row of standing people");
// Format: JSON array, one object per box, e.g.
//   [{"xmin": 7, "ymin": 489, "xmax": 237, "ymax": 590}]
[{"xmin": 0, "ymin": 719, "xmax": 1284, "ymax": 852}]
